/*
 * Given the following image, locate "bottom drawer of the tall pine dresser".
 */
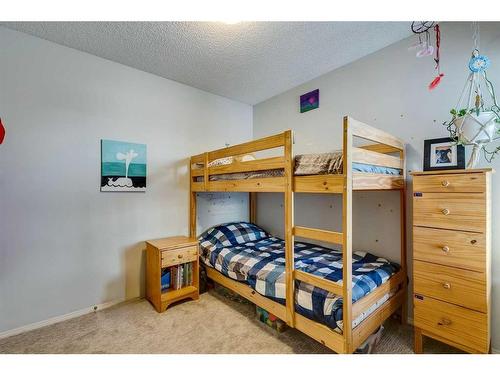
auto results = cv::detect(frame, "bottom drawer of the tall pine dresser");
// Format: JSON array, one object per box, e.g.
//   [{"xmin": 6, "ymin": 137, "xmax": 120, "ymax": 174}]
[{"xmin": 413, "ymin": 295, "xmax": 489, "ymax": 353}]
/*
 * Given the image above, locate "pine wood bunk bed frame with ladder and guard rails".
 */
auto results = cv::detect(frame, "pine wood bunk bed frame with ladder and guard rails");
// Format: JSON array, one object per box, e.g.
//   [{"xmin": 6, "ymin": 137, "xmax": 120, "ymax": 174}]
[{"xmin": 190, "ymin": 116, "xmax": 407, "ymax": 353}]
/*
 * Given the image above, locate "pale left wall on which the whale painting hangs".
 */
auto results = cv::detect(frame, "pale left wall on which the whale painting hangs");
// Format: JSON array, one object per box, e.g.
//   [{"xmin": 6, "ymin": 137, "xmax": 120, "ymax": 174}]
[{"xmin": 0, "ymin": 27, "xmax": 252, "ymax": 332}]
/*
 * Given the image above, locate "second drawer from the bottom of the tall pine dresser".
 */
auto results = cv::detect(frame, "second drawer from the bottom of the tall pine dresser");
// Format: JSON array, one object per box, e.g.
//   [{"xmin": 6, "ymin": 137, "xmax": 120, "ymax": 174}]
[{"xmin": 413, "ymin": 260, "xmax": 488, "ymax": 312}]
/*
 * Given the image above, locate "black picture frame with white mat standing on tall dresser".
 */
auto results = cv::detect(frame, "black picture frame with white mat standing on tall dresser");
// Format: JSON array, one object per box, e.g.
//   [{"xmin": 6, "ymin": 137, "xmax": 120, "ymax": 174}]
[{"xmin": 424, "ymin": 137, "xmax": 465, "ymax": 171}]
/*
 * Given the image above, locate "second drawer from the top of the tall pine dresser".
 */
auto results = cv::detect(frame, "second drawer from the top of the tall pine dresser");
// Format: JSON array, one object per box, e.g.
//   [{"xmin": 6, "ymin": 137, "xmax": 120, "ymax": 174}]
[{"xmin": 413, "ymin": 193, "xmax": 486, "ymax": 233}]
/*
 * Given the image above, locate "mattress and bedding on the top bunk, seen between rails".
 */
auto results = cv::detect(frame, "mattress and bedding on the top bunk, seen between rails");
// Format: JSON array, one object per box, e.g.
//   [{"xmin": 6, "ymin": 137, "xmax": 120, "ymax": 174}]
[{"xmin": 196, "ymin": 152, "xmax": 401, "ymax": 182}]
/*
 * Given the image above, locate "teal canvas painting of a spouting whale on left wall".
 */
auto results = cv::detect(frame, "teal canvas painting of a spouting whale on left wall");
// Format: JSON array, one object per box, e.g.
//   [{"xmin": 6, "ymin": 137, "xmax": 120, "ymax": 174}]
[{"xmin": 101, "ymin": 139, "xmax": 147, "ymax": 191}]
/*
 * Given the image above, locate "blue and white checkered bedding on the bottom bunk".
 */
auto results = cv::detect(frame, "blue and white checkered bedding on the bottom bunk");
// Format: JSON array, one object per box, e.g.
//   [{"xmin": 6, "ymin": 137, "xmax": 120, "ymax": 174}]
[{"xmin": 199, "ymin": 222, "xmax": 399, "ymax": 331}]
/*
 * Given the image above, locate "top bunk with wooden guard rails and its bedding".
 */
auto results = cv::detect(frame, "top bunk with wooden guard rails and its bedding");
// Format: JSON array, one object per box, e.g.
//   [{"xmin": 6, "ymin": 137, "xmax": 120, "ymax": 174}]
[{"xmin": 190, "ymin": 116, "xmax": 405, "ymax": 193}]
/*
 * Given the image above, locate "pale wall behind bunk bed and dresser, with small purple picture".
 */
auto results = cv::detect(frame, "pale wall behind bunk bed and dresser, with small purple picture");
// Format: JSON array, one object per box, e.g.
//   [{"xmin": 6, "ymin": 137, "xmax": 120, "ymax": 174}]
[{"xmin": 254, "ymin": 23, "xmax": 500, "ymax": 349}]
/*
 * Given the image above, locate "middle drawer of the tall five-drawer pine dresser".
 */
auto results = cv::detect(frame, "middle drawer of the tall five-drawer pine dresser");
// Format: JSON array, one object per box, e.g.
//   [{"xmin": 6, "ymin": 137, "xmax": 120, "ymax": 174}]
[{"xmin": 413, "ymin": 226, "xmax": 486, "ymax": 272}]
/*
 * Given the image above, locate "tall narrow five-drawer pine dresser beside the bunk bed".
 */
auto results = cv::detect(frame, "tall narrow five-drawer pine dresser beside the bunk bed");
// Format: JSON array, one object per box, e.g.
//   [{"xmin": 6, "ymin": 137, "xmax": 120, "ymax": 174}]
[{"xmin": 412, "ymin": 169, "xmax": 492, "ymax": 353}]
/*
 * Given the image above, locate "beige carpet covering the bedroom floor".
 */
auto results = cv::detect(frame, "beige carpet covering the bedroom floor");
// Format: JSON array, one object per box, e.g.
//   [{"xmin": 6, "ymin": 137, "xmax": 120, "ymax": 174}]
[{"xmin": 0, "ymin": 291, "xmax": 459, "ymax": 353}]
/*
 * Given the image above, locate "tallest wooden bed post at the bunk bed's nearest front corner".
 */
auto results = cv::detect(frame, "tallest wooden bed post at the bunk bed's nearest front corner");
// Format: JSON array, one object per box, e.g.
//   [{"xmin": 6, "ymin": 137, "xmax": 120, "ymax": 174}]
[{"xmin": 342, "ymin": 116, "xmax": 355, "ymax": 353}]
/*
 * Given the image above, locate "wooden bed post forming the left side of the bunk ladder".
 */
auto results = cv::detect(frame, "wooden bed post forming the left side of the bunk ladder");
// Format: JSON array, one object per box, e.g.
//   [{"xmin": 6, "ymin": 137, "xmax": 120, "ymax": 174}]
[{"xmin": 284, "ymin": 130, "xmax": 295, "ymax": 327}]
